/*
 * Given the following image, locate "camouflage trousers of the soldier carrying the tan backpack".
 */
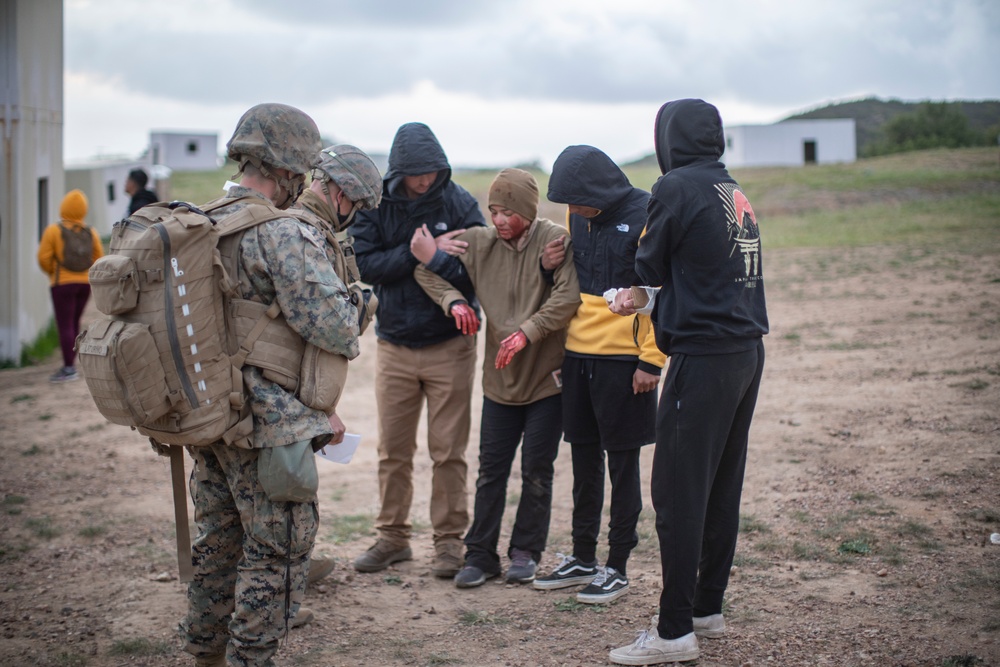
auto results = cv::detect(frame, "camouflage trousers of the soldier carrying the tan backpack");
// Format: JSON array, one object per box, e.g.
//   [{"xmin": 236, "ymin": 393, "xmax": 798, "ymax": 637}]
[{"xmin": 180, "ymin": 445, "xmax": 319, "ymax": 667}]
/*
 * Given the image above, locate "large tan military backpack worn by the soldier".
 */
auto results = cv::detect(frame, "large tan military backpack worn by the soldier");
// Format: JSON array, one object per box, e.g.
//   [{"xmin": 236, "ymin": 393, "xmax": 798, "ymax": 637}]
[{"xmin": 76, "ymin": 198, "xmax": 358, "ymax": 581}]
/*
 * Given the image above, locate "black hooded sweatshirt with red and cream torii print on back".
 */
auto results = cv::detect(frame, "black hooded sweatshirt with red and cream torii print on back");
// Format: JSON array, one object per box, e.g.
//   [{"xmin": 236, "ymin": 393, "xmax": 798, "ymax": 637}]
[{"xmin": 636, "ymin": 99, "xmax": 768, "ymax": 355}]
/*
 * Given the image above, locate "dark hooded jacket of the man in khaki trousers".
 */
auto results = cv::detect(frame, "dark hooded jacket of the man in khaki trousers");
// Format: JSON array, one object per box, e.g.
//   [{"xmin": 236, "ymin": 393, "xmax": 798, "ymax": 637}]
[{"xmin": 350, "ymin": 123, "xmax": 486, "ymax": 348}]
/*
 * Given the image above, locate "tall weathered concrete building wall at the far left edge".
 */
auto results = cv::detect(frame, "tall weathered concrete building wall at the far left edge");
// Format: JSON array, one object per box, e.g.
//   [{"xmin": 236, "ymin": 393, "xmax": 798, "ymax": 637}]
[{"xmin": 0, "ymin": 0, "xmax": 66, "ymax": 362}]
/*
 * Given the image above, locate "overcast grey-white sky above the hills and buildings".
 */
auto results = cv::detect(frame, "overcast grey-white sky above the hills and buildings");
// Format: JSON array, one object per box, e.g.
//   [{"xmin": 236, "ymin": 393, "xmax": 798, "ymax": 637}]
[{"xmin": 65, "ymin": 0, "xmax": 1000, "ymax": 167}]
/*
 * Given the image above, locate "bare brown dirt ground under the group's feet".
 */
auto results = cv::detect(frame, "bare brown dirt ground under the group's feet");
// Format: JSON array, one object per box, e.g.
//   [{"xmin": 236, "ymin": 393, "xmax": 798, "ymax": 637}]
[{"xmin": 0, "ymin": 241, "xmax": 1000, "ymax": 667}]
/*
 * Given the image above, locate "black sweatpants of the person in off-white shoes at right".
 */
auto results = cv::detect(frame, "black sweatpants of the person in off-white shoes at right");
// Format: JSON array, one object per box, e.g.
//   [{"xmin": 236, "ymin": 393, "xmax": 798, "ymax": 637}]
[{"xmin": 651, "ymin": 342, "xmax": 764, "ymax": 639}]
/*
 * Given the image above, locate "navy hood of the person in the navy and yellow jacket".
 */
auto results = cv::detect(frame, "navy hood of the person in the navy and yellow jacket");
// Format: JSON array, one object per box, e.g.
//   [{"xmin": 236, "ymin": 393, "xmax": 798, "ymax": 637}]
[{"xmin": 548, "ymin": 146, "xmax": 633, "ymax": 211}]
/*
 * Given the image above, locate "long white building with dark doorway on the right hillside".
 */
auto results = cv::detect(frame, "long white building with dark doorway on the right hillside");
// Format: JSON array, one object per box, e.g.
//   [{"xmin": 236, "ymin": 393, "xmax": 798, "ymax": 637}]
[{"xmin": 722, "ymin": 118, "xmax": 858, "ymax": 167}]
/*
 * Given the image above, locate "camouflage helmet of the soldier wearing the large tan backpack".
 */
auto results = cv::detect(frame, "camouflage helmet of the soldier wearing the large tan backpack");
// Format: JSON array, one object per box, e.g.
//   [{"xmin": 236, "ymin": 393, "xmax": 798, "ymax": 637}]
[{"xmin": 226, "ymin": 102, "xmax": 322, "ymax": 175}]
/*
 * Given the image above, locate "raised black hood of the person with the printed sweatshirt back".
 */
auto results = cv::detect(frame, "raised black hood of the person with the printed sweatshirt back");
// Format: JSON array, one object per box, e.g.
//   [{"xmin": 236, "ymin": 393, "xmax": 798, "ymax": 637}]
[{"xmin": 654, "ymin": 100, "xmax": 726, "ymax": 174}]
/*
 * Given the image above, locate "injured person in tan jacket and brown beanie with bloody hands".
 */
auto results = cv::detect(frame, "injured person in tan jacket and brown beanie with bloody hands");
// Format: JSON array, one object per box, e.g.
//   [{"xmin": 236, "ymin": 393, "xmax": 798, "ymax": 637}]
[{"xmin": 410, "ymin": 169, "xmax": 580, "ymax": 588}]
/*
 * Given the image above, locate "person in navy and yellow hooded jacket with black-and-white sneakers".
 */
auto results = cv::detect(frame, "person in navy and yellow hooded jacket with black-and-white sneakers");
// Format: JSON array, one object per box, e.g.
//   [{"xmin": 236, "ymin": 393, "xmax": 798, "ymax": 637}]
[{"xmin": 533, "ymin": 145, "xmax": 666, "ymax": 604}]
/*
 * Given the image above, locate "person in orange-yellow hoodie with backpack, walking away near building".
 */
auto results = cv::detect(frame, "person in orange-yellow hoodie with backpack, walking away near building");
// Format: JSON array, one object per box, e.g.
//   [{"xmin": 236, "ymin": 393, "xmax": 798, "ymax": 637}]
[{"xmin": 38, "ymin": 190, "xmax": 104, "ymax": 382}]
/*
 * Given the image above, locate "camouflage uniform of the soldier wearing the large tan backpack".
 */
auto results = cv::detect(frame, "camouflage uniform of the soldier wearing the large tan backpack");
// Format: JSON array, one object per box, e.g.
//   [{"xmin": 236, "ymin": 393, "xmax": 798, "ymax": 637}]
[{"xmin": 180, "ymin": 105, "xmax": 359, "ymax": 667}]
